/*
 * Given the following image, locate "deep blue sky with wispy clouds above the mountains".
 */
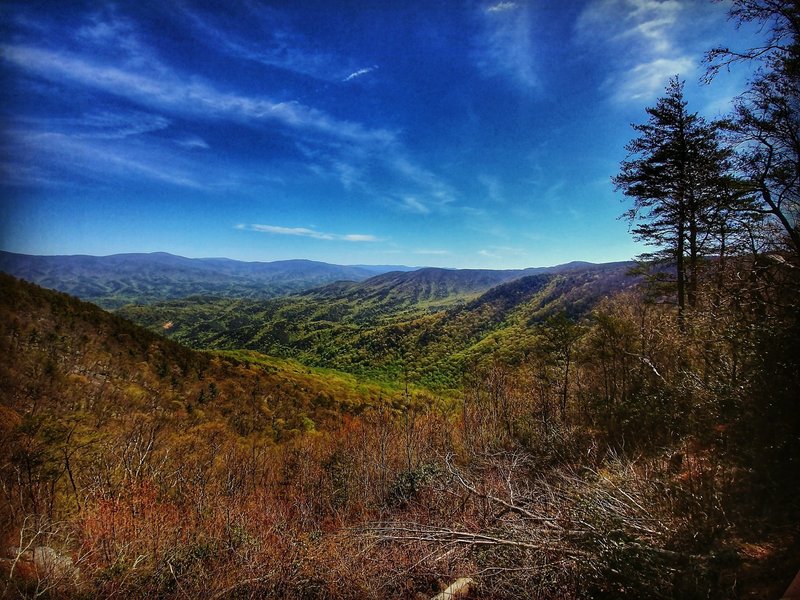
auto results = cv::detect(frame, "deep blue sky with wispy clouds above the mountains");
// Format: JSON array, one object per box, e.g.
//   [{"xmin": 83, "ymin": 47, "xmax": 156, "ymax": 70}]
[{"xmin": 0, "ymin": 0, "xmax": 752, "ymax": 268}]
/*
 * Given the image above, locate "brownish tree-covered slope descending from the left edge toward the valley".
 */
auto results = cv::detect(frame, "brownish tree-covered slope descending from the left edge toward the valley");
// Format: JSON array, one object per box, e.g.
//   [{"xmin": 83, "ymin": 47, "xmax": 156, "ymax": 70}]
[{"xmin": 0, "ymin": 273, "xmax": 400, "ymax": 439}]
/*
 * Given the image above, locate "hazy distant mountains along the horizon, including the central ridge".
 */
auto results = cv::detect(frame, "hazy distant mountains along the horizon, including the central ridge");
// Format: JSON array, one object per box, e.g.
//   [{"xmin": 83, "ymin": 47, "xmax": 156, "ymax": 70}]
[{"xmin": 0, "ymin": 251, "xmax": 628, "ymax": 312}]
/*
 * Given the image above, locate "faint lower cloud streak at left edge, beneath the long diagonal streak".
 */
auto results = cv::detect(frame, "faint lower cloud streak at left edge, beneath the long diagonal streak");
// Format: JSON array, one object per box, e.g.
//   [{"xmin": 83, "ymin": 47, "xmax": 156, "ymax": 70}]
[{"xmin": 0, "ymin": 109, "xmax": 283, "ymax": 192}]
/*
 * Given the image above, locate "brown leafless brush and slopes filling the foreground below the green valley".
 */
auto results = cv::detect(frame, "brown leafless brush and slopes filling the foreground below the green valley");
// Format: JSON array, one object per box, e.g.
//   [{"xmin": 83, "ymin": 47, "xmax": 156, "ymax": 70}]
[{"xmin": 0, "ymin": 243, "xmax": 798, "ymax": 598}]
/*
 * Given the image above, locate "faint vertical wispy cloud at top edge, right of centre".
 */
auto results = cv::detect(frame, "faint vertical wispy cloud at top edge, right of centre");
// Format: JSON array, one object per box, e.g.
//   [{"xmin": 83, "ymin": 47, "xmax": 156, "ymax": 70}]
[{"xmin": 474, "ymin": 2, "xmax": 538, "ymax": 89}]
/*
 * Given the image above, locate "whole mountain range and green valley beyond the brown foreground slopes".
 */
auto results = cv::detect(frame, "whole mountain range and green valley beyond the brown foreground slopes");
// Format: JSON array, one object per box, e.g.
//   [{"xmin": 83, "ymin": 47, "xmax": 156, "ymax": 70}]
[{"xmin": 0, "ymin": 252, "xmax": 638, "ymax": 390}]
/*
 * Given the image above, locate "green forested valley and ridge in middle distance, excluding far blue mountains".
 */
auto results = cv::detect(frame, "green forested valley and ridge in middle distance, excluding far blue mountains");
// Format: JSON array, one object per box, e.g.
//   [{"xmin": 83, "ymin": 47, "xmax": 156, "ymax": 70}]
[{"xmin": 119, "ymin": 263, "xmax": 637, "ymax": 389}]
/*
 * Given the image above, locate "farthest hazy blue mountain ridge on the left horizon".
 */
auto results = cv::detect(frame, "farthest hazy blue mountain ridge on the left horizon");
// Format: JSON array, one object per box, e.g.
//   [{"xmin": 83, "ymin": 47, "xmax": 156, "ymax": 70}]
[{"xmin": 0, "ymin": 251, "xmax": 418, "ymax": 308}]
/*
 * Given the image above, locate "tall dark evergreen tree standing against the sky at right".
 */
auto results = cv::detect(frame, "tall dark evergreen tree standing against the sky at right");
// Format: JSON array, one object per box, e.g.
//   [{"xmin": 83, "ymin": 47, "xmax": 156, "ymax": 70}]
[{"xmin": 613, "ymin": 77, "xmax": 731, "ymax": 323}]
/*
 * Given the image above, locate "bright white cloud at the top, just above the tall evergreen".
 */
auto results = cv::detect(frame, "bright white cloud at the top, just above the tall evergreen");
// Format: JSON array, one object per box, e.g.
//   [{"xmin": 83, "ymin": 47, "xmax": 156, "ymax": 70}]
[{"xmin": 576, "ymin": 0, "xmax": 696, "ymax": 102}]
